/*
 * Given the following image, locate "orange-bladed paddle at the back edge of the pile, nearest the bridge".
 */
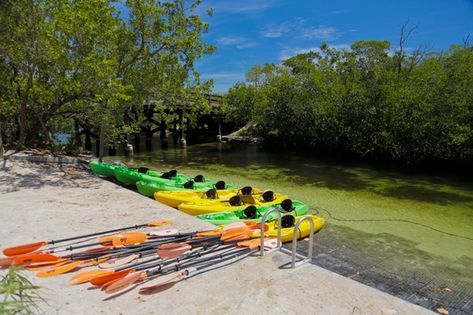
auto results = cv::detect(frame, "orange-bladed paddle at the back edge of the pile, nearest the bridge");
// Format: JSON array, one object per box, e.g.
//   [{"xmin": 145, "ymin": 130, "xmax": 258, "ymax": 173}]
[{"xmin": 3, "ymin": 220, "xmax": 172, "ymax": 256}]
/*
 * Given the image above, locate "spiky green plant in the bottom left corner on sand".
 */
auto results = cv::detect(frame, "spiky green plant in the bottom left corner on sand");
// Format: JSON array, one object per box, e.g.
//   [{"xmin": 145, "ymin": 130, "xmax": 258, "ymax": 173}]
[{"xmin": 0, "ymin": 267, "xmax": 42, "ymax": 314}]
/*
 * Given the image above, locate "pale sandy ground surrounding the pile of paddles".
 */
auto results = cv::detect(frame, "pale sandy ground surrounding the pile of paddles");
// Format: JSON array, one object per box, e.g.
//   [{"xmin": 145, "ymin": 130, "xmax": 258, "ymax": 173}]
[{"xmin": 0, "ymin": 161, "xmax": 431, "ymax": 314}]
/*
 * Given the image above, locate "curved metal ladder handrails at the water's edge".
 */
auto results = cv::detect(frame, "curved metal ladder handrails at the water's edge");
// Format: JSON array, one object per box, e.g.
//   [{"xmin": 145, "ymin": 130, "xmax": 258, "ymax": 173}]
[{"xmin": 260, "ymin": 208, "xmax": 314, "ymax": 268}]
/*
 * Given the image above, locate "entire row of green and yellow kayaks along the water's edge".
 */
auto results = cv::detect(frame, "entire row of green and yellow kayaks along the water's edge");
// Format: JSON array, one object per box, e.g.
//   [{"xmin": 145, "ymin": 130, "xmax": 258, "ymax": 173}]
[{"xmin": 90, "ymin": 160, "xmax": 325, "ymax": 241}]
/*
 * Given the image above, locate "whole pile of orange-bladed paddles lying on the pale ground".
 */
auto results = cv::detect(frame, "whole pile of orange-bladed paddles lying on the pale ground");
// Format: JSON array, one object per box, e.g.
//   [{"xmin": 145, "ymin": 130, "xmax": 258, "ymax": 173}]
[{"xmin": 0, "ymin": 221, "xmax": 277, "ymax": 294}]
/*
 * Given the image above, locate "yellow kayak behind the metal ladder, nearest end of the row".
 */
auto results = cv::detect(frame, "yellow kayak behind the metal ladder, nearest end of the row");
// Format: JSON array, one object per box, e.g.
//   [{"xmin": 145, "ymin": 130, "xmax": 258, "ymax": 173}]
[{"xmin": 253, "ymin": 214, "xmax": 325, "ymax": 243}]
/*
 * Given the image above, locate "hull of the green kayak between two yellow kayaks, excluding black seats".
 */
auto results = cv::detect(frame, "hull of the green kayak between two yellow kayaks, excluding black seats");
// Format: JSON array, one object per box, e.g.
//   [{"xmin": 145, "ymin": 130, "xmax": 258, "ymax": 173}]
[{"xmin": 197, "ymin": 200, "xmax": 309, "ymax": 226}]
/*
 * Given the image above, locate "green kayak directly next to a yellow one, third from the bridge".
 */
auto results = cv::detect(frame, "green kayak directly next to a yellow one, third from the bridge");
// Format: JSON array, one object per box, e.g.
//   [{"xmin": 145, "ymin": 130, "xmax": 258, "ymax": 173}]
[{"xmin": 136, "ymin": 175, "xmax": 234, "ymax": 197}]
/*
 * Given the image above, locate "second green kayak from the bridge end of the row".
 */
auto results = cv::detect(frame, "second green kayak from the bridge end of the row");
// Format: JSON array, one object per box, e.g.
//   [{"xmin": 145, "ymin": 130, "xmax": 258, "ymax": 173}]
[{"xmin": 113, "ymin": 167, "xmax": 188, "ymax": 186}]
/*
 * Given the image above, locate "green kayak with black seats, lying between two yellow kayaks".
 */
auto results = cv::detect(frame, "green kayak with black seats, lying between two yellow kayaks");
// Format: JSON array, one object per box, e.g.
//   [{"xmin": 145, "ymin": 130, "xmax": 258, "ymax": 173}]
[{"xmin": 197, "ymin": 199, "xmax": 309, "ymax": 225}]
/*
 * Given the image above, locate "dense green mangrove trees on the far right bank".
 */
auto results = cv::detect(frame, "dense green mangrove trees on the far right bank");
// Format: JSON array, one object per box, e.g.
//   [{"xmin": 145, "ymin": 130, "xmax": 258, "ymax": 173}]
[{"xmin": 226, "ymin": 41, "xmax": 473, "ymax": 161}]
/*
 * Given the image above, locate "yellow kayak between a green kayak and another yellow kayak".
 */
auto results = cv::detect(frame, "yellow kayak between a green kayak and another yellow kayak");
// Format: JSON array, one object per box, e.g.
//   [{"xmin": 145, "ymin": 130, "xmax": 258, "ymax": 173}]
[{"xmin": 154, "ymin": 186, "xmax": 263, "ymax": 208}]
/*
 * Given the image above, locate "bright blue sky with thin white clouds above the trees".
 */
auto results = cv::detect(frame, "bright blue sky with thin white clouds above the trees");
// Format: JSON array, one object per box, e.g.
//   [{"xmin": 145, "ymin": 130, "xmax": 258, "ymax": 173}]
[{"xmin": 193, "ymin": 0, "xmax": 473, "ymax": 93}]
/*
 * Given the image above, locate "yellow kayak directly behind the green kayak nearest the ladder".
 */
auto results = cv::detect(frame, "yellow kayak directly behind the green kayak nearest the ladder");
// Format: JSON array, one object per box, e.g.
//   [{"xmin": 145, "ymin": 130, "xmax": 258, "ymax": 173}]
[{"xmin": 177, "ymin": 190, "xmax": 287, "ymax": 215}]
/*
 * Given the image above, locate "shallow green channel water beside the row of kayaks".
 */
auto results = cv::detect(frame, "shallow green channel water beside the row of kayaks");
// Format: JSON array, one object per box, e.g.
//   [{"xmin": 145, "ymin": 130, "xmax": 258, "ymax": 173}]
[{"xmin": 108, "ymin": 143, "xmax": 473, "ymax": 260}]
